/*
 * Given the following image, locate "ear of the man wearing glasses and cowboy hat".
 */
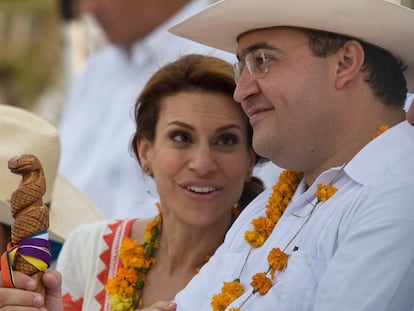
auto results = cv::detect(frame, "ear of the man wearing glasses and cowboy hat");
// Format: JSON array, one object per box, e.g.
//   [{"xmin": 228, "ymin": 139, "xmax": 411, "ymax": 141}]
[{"xmin": 335, "ymin": 40, "xmax": 365, "ymax": 89}]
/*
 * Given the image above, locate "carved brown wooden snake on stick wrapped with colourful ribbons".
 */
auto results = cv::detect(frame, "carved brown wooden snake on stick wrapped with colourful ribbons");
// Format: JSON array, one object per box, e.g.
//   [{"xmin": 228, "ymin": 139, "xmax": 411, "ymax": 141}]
[{"xmin": 8, "ymin": 154, "xmax": 49, "ymax": 275}]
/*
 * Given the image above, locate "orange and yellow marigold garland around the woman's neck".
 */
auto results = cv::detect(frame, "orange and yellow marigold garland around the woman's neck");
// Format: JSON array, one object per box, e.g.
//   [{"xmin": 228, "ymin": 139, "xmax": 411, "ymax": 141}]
[{"xmin": 105, "ymin": 213, "xmax": 162, "ymax": 311}]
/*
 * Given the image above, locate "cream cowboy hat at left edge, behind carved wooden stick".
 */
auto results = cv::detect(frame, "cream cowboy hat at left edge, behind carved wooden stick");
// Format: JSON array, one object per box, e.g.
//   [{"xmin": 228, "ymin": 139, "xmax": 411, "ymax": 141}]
[{"xmin": 0, "ymin": 104, "xmax": 104, "ymax": 242}]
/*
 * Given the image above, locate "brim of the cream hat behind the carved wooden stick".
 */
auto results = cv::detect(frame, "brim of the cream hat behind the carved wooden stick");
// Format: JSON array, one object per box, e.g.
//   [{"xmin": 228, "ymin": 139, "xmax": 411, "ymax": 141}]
[{"xmin": 0, "ymin": 174, "xmax": 105, "ymax": 243}]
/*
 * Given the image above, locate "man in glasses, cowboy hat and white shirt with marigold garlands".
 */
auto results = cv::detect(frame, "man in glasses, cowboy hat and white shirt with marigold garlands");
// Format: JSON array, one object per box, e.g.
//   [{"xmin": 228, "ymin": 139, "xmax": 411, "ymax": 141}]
[{"xmin": 0, "ymin": 0, "xmax": 414, "ymax": 311}]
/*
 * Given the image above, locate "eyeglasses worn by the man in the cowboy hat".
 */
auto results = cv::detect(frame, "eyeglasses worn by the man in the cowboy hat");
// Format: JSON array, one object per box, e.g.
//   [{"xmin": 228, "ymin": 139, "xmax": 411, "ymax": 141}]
[{"xmin": 233, "ymin": 49, "xmax": 271, "ymax": 83}]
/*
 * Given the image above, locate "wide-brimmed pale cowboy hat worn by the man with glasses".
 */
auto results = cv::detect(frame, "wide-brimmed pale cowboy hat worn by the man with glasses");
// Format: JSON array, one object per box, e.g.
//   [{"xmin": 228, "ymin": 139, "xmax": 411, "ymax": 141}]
[{"xmin": 170, "ymin": 0, "xmax": 414, "ymax": 92}]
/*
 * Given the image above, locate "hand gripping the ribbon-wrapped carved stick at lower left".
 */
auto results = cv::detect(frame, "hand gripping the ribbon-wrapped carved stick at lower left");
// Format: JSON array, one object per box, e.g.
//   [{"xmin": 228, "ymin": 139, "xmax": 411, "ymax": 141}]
[{"xmin": 0, "ymin": 270, "xmax": 63, "ymax": 311}]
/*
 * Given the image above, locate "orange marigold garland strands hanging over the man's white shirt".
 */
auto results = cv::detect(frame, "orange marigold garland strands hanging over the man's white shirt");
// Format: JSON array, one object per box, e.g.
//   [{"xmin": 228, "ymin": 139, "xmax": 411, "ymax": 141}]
[{"xmin": 210, "ymin": 125, "xmax": 389, "ymax": 311}]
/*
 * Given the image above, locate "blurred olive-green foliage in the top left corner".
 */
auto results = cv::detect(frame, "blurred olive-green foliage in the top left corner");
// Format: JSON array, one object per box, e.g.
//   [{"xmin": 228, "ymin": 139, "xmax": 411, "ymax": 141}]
[{"xmin": 0, "ymin": 0, "xmax": 62, "ymax": 109}]
